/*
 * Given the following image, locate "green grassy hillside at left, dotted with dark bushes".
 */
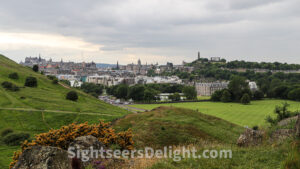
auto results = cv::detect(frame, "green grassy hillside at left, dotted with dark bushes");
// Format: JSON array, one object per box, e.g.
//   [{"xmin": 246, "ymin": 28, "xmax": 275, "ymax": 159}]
[{"xmin": 0, "ymin": 55, "xmax": 128, "ymax": 168}]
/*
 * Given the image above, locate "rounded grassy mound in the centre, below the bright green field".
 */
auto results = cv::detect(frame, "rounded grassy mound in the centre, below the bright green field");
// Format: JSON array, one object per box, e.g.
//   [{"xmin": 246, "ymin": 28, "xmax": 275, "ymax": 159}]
[{"xmin": 114, "ymin": 107, "xmax": 243, "ymax": 147}]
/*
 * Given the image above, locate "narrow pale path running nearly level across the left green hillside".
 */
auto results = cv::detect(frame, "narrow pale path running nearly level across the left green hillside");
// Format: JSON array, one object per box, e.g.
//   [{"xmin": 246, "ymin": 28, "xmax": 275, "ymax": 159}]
[{"xmin": 0, "ymin": 108, "xmax": 116, "ymax": 116}]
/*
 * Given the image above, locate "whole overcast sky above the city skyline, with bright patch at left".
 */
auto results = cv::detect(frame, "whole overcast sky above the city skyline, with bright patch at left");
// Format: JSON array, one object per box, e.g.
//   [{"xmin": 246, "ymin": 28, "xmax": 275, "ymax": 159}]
[{"xmin": 0, "ymin": 0, "xmax": 300, "ymax": 64}]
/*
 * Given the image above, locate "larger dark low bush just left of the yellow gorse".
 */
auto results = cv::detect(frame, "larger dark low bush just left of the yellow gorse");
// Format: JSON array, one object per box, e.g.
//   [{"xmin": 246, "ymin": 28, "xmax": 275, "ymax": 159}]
[{"xmin": 3, "ymin": 133, "xmax": 30, "ymax": 146}]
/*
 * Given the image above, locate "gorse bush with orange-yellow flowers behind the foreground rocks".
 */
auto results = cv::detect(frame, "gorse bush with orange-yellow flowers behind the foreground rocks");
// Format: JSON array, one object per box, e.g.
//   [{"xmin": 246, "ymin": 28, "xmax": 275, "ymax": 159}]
[{"xmin": 10, "ymin": 121, "xmax": 133, "ymax": 169}]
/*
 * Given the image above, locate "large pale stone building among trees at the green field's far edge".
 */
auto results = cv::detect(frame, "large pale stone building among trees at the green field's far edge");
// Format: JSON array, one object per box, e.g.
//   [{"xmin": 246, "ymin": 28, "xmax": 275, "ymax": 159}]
[{"xmin": 195, "ymin": 82, "xmax": 229, "ymax": 96}]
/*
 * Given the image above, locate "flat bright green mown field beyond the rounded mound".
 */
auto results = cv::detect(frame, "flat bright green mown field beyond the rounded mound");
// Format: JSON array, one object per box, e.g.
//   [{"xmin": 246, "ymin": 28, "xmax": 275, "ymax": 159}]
[{"xmin": 130, "ymin": 100, "xmax": 300, "ymax": 127}]
